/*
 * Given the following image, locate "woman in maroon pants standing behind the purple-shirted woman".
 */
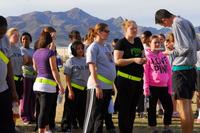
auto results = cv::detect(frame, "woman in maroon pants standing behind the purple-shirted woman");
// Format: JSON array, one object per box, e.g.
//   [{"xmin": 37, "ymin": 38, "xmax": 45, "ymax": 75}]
[{"xmin": 20, "ymin": 32, "xmax": 36, "ymax": 125}]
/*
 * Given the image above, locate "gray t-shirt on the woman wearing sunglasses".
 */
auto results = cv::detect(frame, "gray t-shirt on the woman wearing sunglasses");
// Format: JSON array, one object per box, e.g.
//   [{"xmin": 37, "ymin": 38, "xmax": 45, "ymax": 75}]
[{"xmin": 86, "ymin": 41, "xmax": 116, "ymax": 89}]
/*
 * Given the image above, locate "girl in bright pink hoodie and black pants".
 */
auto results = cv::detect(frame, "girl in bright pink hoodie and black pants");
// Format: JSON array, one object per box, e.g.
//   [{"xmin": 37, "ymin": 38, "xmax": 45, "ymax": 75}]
[{"xmin": 144, "ymin": 35, "xmax": 173, "ymax": 133}]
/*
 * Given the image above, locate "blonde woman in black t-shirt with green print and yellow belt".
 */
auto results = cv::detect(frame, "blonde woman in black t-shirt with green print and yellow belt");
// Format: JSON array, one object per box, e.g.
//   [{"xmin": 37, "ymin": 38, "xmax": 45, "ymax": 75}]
[{"xmin": 114, "ymin": 20, "xmax": 146, "ymax": 133}]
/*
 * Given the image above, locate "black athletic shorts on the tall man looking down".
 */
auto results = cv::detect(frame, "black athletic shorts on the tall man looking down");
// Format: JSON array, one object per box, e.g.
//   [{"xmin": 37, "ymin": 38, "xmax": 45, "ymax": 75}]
[{"xmin": 172, "ymin": 69, "xmax": 196, "ymax": 99}]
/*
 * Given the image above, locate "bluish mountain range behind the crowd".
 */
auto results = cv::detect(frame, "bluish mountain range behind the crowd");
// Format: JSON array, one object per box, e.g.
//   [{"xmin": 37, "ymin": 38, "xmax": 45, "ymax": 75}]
[{"xmin": 7, "ymin": 8, "xmax": 200, "ymax": 46}]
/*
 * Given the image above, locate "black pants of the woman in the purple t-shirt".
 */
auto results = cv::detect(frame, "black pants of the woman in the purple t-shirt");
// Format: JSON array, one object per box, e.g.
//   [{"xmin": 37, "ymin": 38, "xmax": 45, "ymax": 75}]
[{"xmin": 35, "ymin": 92, "xmax": 54, "ymax": 128}]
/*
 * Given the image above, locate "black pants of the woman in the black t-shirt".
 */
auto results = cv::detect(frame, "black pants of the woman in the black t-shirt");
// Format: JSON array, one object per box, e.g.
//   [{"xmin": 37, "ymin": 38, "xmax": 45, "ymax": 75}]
[{"xmin": 118, "ymin": 78, "xmax": 143, "ymax": 133}]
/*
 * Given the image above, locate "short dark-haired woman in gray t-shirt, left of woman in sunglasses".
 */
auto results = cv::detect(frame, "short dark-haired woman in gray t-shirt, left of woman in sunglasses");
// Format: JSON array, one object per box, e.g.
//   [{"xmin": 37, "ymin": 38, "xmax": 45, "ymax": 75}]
[{"xmin": 61, "ymin": 41, "xmax": 89, "ymax": 132}]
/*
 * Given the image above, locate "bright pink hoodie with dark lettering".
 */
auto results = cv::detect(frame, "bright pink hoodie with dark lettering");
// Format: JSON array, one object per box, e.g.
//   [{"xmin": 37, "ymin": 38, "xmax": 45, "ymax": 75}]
[{"xmin": 144, "ymin": 49, "xmax": 172, "ymax": 96}]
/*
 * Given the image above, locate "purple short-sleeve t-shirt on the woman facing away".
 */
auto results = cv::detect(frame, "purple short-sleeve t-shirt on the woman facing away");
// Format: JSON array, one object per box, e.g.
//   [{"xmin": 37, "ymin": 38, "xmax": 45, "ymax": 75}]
[{"xmin": 33, "ymin": 48, "xmax": 55, "ymax": 80}]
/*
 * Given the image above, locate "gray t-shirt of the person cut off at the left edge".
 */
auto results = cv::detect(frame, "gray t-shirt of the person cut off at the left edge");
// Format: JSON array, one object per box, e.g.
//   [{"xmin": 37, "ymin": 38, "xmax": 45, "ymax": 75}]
[{"xmin": 0, "ymin": 36, "xmax": 12, "ymax": 92}]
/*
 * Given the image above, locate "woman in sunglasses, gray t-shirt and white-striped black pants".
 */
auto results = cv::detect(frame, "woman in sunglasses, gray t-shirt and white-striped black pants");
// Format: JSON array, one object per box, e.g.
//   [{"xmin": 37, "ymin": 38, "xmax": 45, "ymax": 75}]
[{"xmin": 83, "ymin": 23, "xmax": 116, "ymax": 133}]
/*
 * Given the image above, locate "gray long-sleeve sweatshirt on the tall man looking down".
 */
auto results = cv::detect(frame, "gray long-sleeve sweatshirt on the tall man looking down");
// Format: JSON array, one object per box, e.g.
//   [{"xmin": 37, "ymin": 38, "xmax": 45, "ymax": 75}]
[{"xmin": 172, "ymin": 17, "xmax": 197, "ymax": 66}]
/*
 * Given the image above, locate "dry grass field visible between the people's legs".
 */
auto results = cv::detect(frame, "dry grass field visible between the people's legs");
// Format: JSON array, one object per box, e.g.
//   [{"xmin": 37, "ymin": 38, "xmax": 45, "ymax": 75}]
[{"xmin": 16, "ymin": 73, "xmax": 200, "ymax": 133}]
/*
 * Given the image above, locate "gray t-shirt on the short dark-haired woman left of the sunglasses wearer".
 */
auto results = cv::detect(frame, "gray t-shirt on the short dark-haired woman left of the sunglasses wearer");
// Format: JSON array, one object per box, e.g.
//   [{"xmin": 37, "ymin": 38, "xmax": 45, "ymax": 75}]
[{"xmin": 64, "ymin": 57, "xmax": 89, "ymax": 87}]
